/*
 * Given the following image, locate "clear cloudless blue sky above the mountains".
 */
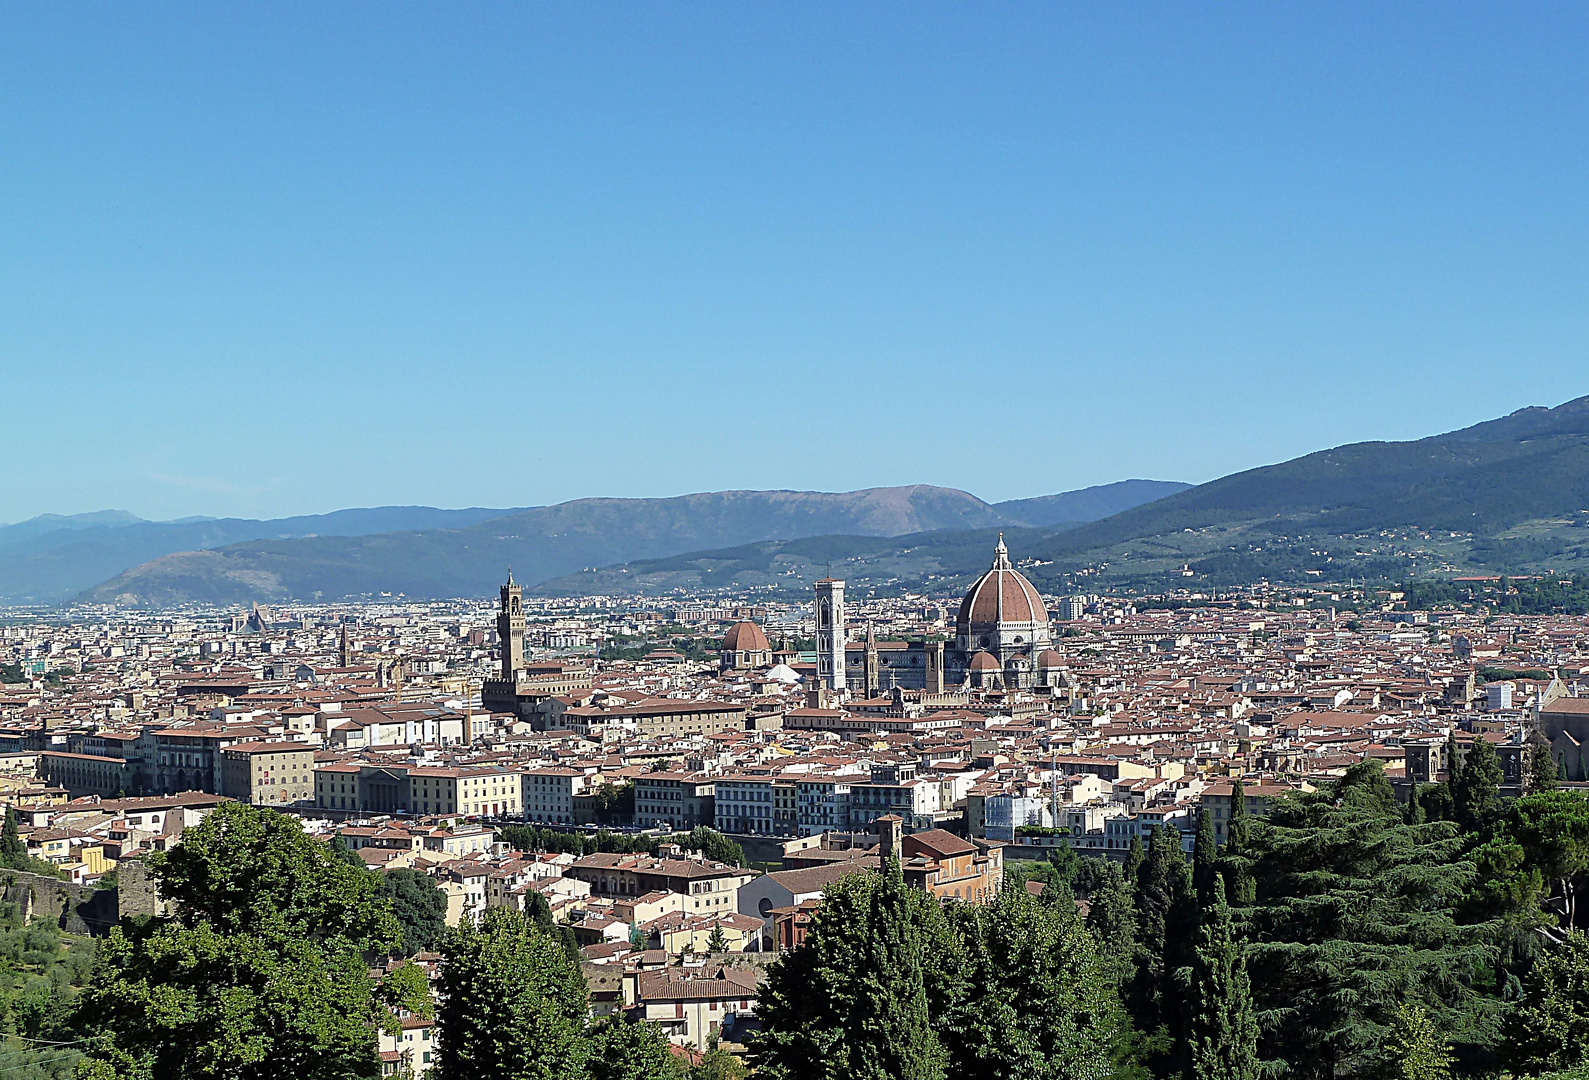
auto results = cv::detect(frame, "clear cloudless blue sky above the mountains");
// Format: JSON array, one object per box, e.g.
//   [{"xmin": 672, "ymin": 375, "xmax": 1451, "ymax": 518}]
[{"xmin": 0, "ymin": 3, "xmax": 1589, "ymax": 521}]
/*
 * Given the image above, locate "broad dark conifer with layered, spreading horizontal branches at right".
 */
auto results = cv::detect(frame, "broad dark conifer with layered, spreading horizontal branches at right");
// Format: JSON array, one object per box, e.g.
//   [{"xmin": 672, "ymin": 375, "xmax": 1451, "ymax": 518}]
[{"xmin": 1236, "ymin": 761, "xmax": 1505, "ymax": 1080}]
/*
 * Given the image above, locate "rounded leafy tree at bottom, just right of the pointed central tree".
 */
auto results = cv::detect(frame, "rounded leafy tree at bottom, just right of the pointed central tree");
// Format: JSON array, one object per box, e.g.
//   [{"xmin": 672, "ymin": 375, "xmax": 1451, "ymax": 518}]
[{"xmin": 934, "ymin": 889, "xmax": 1128, "ymax": 1080}]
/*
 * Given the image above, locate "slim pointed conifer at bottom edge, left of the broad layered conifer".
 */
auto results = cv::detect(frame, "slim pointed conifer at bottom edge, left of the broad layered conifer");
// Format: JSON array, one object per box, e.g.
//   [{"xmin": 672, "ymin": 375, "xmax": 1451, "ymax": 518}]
[{"xmin": 1185, "ymin": 878, "xmax": 1260, "ymax": 1080}]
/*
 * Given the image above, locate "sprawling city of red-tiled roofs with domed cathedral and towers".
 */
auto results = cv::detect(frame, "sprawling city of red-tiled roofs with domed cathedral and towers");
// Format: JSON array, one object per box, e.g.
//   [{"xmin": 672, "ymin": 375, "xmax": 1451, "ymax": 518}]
[{"xmin": 0, "ymin": 542, "xmax": 1589, "ymax": 1075}]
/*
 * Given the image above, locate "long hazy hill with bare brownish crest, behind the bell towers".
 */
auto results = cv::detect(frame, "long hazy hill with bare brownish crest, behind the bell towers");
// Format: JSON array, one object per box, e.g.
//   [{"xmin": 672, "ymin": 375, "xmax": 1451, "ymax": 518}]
[{"xmin": 81, "ymin": 481, "xmax": 1194, "ymax": 605}]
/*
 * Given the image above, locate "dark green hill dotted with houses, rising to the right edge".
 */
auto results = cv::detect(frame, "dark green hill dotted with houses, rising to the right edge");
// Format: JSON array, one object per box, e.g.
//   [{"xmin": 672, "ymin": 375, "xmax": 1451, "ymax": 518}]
[{"xmin": 540, "ymin": 397, "xmax": 1589, "ymax": 594}]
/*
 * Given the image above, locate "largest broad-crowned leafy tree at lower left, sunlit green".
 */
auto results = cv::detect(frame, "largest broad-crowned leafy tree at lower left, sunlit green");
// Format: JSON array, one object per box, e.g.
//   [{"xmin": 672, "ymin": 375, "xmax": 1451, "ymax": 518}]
[{"xmin": 81, "ymin": 802, "xmax": 427, "ymax": 1080}]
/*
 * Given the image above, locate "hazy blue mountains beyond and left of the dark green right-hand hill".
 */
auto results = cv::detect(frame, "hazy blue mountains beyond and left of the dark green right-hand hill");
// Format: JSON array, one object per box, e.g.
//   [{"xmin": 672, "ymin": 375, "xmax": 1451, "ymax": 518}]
[{"xmin": 12, "ymin": 480, "xmax": 1187, "ymax": 604}]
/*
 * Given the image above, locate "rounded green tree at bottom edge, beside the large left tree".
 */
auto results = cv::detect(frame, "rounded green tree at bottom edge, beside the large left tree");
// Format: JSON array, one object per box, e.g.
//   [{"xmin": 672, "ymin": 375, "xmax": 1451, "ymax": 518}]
[{"xmin": 435, "ymin": 907, "xmax": 590, "ymax": 1080}]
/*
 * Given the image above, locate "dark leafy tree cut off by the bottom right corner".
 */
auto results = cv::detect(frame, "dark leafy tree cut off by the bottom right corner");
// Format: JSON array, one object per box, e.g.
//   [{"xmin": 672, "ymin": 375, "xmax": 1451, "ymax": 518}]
[{"xmin": 1508, "ymin": 931, "xmax": 1589, "ymax": 1075}]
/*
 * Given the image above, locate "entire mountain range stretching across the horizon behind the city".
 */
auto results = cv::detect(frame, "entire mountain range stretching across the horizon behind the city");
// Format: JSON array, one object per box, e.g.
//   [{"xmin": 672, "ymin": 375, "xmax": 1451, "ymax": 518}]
[{"xmin": 28, "ymin": 397, "xmax": 1589, "ymax": 605}]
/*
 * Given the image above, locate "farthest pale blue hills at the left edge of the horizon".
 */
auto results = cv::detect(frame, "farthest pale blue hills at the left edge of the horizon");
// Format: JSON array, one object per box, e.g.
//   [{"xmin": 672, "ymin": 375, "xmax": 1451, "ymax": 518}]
[{"xmin": 0, "ymin": 507, "xmax": 510, "ymax": 604}]
